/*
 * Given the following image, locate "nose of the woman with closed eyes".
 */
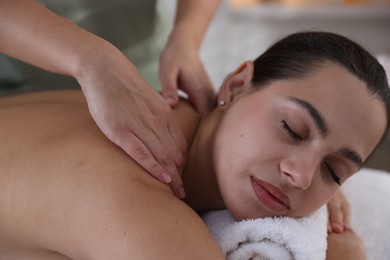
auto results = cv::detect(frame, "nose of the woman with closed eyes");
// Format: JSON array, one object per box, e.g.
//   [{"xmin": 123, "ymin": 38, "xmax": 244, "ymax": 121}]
[{"xmin": 280, "ymin": 156, "xmax": 319, "ymax": 190}]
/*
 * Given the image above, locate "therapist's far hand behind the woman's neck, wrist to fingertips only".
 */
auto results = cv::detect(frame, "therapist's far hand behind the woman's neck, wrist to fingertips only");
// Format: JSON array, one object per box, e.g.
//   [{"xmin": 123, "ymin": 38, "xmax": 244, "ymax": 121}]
[{"xmin": 160, "ymin": 33, "xmax": 215, "ymax": 114}]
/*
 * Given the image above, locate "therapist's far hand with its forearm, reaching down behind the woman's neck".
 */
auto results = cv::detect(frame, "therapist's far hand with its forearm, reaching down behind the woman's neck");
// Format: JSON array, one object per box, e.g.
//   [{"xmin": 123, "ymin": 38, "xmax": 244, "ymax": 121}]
[{"xmin": 160, "ymin": 0, "xmax": 220, "ymax": 114}]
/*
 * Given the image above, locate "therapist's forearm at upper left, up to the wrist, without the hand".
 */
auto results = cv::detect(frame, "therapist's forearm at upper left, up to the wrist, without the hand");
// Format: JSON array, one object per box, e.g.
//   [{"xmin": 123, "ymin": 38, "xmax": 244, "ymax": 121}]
[{"xmin": 0, "ymin": 0, "xmax": 111, "ymax": 81}]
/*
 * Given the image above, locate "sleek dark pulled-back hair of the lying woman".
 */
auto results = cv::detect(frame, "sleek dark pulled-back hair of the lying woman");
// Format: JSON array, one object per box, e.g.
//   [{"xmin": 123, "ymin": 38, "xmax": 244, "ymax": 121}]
[{"xmin": 252, "ymin": 32, "xmax": 390, "ymax": 143}]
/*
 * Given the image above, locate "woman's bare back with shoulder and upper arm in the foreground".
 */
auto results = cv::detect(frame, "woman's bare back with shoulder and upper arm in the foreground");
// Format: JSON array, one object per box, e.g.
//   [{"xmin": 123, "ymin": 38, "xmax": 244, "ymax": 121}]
[{"xmin": 0, "ymin": 91, "xmax": 223, "ymax": 259}]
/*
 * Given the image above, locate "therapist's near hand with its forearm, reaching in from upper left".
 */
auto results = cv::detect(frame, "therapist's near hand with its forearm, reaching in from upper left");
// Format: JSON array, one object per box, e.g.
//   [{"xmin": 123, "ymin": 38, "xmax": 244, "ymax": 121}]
[{"xmin": 0, "ymin": 0, "xmax": 187, "ymax": 197}]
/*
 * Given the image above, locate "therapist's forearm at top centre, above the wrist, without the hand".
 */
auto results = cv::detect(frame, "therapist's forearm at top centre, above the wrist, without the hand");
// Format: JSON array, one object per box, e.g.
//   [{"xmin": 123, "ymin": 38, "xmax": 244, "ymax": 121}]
[{"xmin": 172, "ymin": 0, "xmax": 221, "ymax": 49}]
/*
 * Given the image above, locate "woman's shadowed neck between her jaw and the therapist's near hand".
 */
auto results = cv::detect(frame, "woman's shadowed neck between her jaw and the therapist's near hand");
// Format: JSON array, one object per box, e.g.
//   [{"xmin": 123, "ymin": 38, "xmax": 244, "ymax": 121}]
[{"xmin": 182, "ymin": 110, "xmax": 224, "ymax": 211}]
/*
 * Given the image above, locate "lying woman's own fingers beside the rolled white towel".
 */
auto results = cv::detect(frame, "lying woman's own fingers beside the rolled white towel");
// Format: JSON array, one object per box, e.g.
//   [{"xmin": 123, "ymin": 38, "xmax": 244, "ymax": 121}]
[{"xmin": 327, "ymin": 190, "xmax": 351, "ymax": 233}]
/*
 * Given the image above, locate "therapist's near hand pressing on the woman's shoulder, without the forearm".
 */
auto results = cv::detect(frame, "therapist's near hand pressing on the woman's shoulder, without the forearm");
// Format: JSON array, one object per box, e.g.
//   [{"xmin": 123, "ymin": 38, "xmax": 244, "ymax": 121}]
[{"xmin": 77, "ymin": 45, "xmax": 187, "ymax": 198}]
